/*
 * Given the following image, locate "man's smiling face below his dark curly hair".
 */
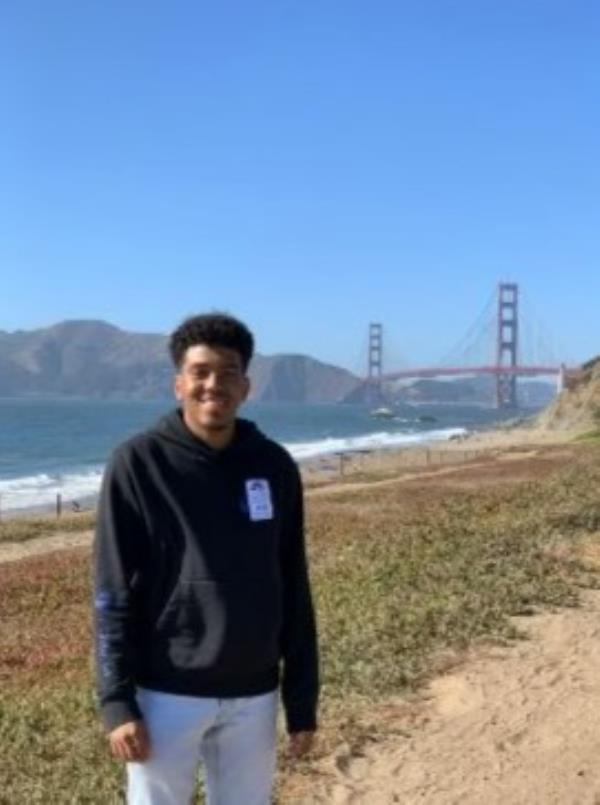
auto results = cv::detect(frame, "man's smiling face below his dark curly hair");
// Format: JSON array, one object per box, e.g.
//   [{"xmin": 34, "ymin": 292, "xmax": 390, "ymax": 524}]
[{"xmin": 175, "ymin": 344, "xmax": 250, "ymax": 436}]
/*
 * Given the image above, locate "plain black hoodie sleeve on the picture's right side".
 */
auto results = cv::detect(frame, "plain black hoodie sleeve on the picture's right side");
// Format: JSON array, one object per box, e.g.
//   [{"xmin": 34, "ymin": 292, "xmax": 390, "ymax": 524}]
[{"xmin": 282, "ymin": 458, "xmax": 319, "ymax": 733}]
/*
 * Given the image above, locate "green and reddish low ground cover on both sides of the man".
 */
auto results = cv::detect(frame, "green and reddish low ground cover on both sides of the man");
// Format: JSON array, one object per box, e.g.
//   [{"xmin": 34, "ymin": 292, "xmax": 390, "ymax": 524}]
[{"xmin": 0, "ymin": 445, "xmax": 600, "ymax": 805}]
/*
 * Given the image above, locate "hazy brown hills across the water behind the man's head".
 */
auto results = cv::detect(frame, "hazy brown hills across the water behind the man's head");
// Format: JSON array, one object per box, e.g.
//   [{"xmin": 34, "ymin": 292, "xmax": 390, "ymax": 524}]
[{"xmin": 0, "ymin": 320, "xmax": 360, "ymax": 402}]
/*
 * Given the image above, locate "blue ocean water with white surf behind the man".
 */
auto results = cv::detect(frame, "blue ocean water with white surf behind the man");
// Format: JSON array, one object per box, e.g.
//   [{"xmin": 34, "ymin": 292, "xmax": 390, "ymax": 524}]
[{"xmin": 0, "ymin": 399, "xmax": 514, "ymax": 512}]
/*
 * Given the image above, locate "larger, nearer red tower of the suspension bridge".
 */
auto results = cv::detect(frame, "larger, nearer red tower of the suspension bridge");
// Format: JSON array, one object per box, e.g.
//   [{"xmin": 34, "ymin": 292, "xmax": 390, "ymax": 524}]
[{"xmin": 496, "ymin": 282, "xmax": 519, "ymax": 408}]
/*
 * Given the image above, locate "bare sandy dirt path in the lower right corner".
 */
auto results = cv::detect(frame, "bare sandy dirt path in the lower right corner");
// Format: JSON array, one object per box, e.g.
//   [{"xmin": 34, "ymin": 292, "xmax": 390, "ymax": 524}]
[{"xmin": 297, "ymin": 591, "xmax": 600, "ymax": 805}]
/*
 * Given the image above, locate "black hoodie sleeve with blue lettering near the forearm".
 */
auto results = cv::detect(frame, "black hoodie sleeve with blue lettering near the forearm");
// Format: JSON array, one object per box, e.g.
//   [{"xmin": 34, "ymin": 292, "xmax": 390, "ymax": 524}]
[{"xmin": 93, "ymin": 453, "xmax": 144, "ymax": 731}]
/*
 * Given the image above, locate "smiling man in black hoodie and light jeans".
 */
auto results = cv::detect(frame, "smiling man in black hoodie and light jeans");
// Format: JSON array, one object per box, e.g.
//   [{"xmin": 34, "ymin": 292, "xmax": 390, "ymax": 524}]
[{"xmin": 94, "ymin": 314, "xmax": 318, "ymax": 805}]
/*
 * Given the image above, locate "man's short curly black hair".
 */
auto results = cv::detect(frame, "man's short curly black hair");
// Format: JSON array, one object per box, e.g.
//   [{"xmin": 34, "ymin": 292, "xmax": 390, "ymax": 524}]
[{"xmin": 169, "ymin": 311, "xmax": 254, "ymax": 372}]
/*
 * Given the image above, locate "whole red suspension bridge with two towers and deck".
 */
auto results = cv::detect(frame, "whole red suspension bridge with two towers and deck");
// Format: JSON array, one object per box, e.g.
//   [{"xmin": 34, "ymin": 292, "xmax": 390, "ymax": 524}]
[{"xmin": 364, "ymin": 282, "xmax": 578, "ymax": 408}]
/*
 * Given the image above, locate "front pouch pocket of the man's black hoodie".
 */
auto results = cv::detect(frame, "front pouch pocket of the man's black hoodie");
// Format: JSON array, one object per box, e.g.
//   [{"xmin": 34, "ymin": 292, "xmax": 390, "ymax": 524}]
[{"xmin": 150, "ymin": 578, "xmax": 281, "ymax": 678}]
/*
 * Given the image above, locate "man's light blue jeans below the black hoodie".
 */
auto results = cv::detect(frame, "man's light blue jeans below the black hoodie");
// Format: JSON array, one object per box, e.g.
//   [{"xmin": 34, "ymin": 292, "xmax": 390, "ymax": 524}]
[{"xmin": 127, "ymin": 689, "xmax": 277, "ymax": 805}]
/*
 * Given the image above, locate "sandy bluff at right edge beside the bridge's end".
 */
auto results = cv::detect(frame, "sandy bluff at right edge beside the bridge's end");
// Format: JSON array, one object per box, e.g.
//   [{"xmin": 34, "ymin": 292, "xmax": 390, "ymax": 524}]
[{"xmin": 535, "ymin": 356, "xmax": 600, "ymax": 431}]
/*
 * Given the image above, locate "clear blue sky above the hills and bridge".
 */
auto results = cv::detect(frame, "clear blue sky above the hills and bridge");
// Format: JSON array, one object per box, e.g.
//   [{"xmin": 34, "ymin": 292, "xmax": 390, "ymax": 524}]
[{"xmin": 0, "ymin": 0, "xmax": 600, "ymax": 370}]
